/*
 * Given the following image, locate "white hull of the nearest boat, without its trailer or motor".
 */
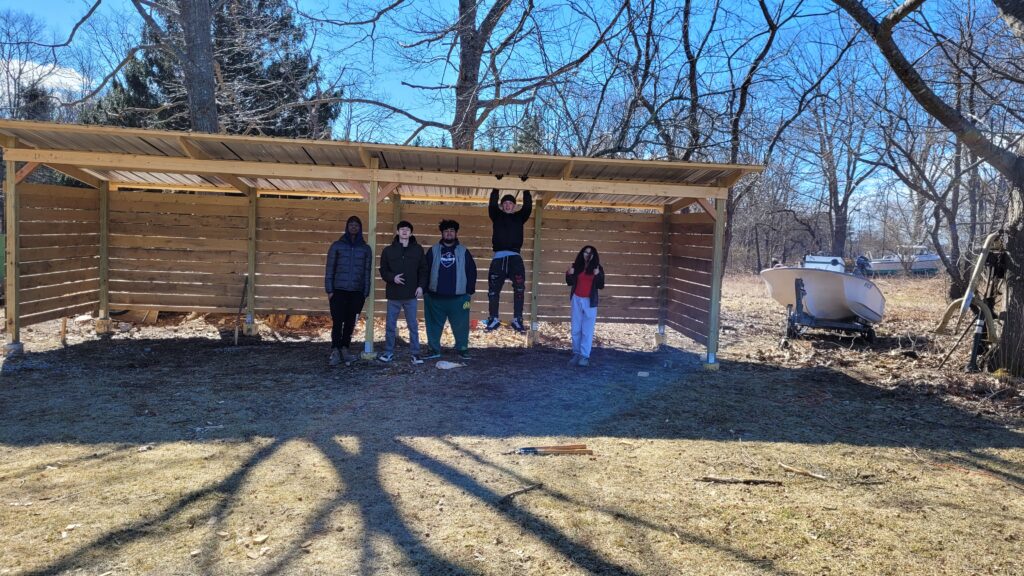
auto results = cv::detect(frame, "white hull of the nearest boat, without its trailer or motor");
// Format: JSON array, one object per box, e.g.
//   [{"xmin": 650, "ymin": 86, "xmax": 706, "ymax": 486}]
[{"xmin": 761, "ymin": 266, "xmax": 886, "ymax": 324}]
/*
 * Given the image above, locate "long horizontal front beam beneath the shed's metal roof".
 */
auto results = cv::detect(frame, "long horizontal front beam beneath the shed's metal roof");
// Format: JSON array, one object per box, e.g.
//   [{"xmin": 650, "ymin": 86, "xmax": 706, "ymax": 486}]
[{"xmin": 6, "ymin": 149, "xmax": 728, "ymax": 198}]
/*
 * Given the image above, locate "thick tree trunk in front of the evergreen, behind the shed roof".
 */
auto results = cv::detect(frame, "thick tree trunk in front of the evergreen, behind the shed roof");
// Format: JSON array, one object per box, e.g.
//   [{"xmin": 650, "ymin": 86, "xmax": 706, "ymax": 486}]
[{"xmin": 178, "ymin": 0, "xmax": 220, "ymax": 132}]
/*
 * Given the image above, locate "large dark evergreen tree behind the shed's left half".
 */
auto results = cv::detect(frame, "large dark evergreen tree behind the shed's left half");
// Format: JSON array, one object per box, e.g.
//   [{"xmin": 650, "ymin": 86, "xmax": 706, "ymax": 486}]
[{"xmin": 87, "ymin": 0, "xmax": 341, "ymax": 138}]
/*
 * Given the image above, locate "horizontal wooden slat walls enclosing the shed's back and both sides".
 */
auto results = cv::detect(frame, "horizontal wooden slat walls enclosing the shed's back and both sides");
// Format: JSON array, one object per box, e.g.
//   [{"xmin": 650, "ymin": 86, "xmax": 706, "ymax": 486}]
[{"xmin": 18, "ymin": 184, "xmax": 714, "ymax": 343}]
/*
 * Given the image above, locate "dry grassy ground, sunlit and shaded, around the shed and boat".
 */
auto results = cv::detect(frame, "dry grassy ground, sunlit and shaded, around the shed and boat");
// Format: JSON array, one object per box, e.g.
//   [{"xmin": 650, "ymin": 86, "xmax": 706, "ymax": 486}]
[{"xmin": 0, "ymin": 276, "xmax": 1024, "ymax": 575}]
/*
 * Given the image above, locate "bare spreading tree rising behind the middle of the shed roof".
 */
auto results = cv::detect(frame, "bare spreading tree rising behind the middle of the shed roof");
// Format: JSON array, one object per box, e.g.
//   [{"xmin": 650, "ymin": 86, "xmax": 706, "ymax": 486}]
[{"xmin": 305, "ymin": 0, "xmax": 629, "ymax": 149}]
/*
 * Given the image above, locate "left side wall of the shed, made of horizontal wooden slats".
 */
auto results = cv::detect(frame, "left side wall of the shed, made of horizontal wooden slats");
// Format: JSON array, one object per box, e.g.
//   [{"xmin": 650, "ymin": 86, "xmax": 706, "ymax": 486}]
[{"xmin": 17, "ymin": 183, "xmax": 99, "ymax": 326}]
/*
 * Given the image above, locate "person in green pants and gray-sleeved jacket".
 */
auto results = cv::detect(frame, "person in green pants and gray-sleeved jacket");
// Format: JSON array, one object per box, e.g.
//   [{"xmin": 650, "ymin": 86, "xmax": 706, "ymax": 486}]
[{"xmin": 423, "ymin": 220, "xmax": 476, "ymax": 360}]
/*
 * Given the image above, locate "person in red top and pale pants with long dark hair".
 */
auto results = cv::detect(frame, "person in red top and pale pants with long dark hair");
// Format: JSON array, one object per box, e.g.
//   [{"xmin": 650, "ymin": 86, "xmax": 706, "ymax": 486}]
[{"xmin": 565, "ymin": 246, "xmax": 604, "ymax": 366}]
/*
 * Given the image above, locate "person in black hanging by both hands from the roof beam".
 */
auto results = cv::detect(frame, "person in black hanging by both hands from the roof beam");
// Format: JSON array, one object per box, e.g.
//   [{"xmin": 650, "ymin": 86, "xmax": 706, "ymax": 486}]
[{"xmin": 484, "ymin": 188, "xmax": 534, "ymax": 332}]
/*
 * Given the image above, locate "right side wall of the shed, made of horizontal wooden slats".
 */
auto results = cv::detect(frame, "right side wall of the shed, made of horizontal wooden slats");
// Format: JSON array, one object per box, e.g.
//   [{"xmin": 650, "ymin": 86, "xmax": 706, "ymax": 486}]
[{"xmin": 666, "ymin": 213, "xmax": 715, "ymax": 344}]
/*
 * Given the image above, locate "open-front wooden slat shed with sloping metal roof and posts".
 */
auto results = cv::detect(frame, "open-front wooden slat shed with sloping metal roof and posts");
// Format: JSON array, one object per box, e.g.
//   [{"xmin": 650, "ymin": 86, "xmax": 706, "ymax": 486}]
[{"xmin": 0, "ymin": 121, "xmax": 761, "ymax": 366}]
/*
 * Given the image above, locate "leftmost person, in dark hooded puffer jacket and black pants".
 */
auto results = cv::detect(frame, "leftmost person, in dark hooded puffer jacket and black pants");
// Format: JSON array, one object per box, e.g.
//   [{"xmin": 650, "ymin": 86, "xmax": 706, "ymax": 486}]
[{"xmin": 324, "ymin": 216, "xmax": 374, "ymax": 366}]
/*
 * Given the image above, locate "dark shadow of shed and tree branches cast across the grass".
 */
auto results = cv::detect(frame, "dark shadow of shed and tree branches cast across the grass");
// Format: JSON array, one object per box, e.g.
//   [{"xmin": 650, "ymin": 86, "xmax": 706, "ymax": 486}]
[{"xmin": 0, "ymin": 339, "xmax": 1024, "ymax": 574}]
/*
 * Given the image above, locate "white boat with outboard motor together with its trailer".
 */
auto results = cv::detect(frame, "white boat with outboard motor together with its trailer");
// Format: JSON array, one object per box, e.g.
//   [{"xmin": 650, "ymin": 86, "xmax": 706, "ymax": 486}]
[{"xmin": 761, "ymin": 256, "xmax": 886, "ymax": 339}]
